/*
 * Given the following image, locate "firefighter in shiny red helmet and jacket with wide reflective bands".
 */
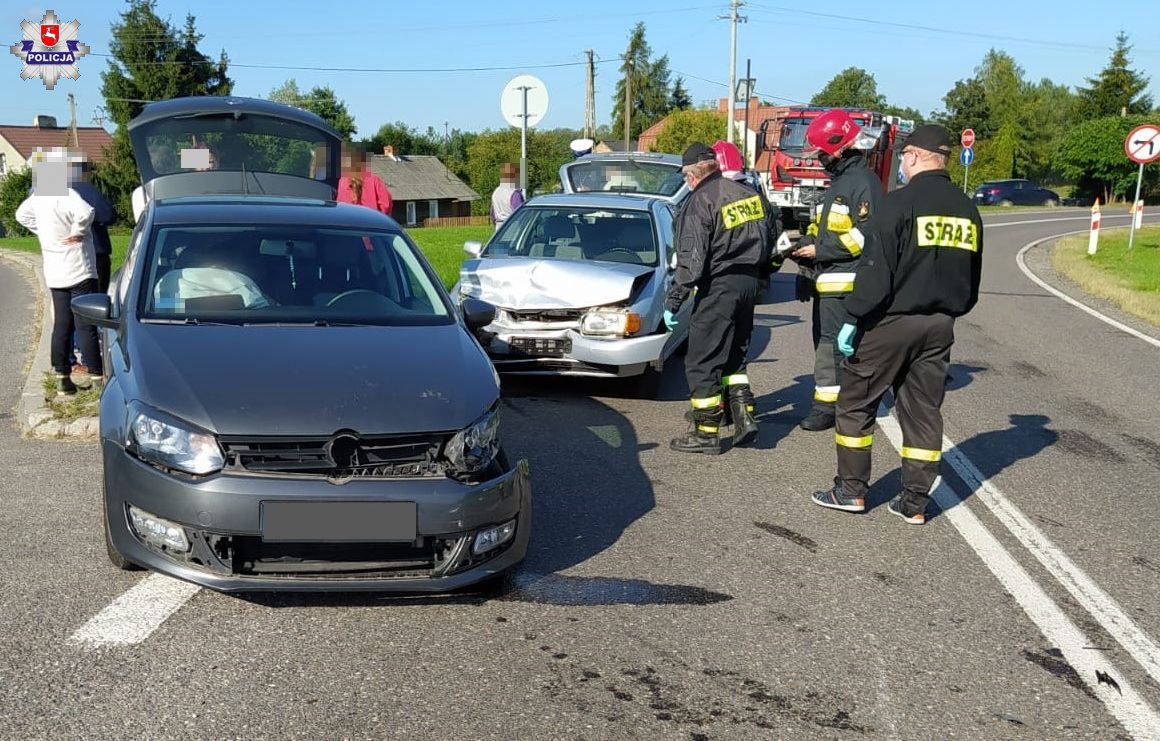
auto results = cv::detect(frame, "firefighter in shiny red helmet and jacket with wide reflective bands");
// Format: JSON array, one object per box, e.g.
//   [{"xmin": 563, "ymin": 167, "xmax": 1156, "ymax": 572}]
[{"xmin": 791, "ymin": 108, "xmax": 883, "ymax": 431}]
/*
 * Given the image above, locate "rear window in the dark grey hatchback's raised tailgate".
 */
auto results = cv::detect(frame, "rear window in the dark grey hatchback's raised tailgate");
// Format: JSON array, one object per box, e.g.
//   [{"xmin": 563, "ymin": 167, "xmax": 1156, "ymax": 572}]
[{"xmin": 136, "ymin": 115, "xmax": 333, "ymax": 180}]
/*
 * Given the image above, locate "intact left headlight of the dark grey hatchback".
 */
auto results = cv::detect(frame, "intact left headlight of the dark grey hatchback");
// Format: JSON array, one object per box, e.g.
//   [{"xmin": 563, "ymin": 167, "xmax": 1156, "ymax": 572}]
[{"xmin": 125, "ymin": 407, "xmax": 225, "ymax": 475}]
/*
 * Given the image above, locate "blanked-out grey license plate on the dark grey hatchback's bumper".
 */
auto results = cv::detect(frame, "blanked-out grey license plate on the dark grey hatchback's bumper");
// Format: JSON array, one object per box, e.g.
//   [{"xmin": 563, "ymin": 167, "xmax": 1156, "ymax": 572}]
[{"xmin": 262, "ymin": 502, "xmax": 419, "ymax": 543}]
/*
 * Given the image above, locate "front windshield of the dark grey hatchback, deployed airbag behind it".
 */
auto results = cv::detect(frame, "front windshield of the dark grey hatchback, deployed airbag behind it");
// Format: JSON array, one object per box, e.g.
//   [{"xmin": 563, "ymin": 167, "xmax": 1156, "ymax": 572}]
[{"xmin": 142, "ymin": 225, "xmax": 454, "ymax": 325}]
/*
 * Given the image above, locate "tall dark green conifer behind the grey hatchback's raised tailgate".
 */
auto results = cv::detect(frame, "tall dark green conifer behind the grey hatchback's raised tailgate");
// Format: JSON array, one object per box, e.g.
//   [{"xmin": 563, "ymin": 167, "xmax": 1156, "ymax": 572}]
[{"xmin": 93, "ymin": 0, "xmax": 233, "ymax": 220}]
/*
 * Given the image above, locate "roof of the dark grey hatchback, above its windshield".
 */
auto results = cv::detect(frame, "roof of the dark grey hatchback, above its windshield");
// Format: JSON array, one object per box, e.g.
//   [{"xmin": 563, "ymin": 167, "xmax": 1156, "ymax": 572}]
[{"xmin": 152, "ymin": 196, "xmax": 403, "ymax": 231}]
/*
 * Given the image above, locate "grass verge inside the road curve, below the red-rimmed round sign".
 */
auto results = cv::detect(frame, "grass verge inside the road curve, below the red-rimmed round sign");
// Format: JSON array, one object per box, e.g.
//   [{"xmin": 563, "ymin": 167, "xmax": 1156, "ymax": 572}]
[{"xmin": 1051, "ymin": 226, "xmax": 1160, "ymax": 326}]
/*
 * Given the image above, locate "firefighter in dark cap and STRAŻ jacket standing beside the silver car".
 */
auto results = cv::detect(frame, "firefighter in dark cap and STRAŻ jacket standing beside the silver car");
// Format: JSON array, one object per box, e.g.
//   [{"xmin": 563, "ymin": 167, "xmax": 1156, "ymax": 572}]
[{"xmin": 665, "ymin": 141, "xmax": 769, "ymax": 455}]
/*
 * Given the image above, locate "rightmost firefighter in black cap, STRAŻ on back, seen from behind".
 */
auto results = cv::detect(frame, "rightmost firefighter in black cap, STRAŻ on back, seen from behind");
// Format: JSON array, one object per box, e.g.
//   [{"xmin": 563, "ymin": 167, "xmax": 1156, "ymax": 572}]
[{"xmin": 813, "ymin": 124, "xmax": 983, "ymax": 525}]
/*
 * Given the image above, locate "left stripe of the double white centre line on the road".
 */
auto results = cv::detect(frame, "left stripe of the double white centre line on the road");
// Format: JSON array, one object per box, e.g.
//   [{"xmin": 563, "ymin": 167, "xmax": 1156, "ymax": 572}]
[{"xmin": 878, "ymin": 407, "xmax": 1160, "ymax": 741}]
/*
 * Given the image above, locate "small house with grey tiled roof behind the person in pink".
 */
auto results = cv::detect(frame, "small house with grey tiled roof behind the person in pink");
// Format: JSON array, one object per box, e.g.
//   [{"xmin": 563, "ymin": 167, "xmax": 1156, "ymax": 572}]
[{"xmin": 367, "ymin": 146, "xmax": 479, "ymax": 226}]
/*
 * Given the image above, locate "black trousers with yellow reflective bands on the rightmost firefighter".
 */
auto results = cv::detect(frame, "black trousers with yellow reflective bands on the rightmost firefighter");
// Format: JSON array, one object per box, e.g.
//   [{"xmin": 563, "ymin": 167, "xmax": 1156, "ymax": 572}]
[{"xmin": 835, "ymin": 314, "xmax": 955, "ymax": 507}]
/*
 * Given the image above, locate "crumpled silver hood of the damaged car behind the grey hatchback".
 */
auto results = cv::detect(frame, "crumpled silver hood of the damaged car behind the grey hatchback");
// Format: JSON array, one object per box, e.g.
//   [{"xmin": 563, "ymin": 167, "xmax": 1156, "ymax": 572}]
[{"xmin": 462, "ymin": 257, "xmax": 655, "ymax": 310}]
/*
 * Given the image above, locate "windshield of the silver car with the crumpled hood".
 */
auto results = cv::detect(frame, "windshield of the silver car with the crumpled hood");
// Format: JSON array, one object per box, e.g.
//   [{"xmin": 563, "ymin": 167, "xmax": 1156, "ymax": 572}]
[{"xmin": 483, "ymin": 206, "xmax": 657, "ymax": 266}]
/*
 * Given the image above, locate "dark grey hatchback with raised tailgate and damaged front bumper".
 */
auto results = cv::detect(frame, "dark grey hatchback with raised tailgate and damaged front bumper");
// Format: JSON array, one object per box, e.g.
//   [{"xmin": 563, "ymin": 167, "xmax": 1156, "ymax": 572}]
[{"xmin": 73, "ymin": 97, "xmax": 531, "ymax": 591}]
